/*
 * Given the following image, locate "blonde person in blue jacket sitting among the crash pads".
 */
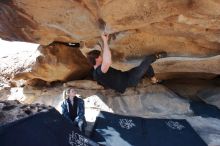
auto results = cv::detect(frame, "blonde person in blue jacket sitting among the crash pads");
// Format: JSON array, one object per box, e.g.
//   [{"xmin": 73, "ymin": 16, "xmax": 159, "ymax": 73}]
[{"xmin": 61, "ymin": 88, "xmax": 87, "ymax": 133}]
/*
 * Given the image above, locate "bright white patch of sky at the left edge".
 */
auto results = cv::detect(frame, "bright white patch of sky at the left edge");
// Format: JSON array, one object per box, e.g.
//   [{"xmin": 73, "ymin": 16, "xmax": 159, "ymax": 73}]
[{"xmin": 0, "ymin": 38, "xmax": 39, "ymax": 57}]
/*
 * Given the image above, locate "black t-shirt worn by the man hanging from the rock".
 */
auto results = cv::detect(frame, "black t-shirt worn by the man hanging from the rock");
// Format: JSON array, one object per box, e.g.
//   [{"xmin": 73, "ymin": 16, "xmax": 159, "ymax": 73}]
[{"xmin": 93, "ymin": 65, "xmax": 128, "ymax": 93}]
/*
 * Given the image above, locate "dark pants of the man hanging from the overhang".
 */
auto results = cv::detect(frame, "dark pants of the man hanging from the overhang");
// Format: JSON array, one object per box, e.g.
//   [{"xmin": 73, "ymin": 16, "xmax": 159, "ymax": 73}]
[{"xmin": 127, "ymin": 55, "xmax": 156, "ymax": 87}]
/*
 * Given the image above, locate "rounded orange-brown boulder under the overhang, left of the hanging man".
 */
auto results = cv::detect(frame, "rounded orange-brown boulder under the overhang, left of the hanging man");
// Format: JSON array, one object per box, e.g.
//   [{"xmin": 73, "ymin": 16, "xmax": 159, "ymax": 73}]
[{"xmin": 14, "ymin": 43, "xmax": 90, "ymax": 84}]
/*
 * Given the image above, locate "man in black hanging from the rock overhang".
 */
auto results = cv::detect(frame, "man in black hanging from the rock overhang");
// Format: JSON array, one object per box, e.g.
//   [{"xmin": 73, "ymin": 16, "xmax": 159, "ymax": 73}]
[{"xmin": 87, "ymin": 33, "xmax": 167, "ymax": 93}]
